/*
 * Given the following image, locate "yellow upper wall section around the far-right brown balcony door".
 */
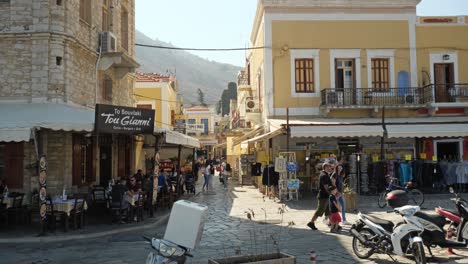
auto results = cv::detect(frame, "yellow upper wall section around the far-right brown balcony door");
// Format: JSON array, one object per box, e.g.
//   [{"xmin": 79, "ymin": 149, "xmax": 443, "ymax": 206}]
[{"xmin": 416, "ymin": 25, "xmax": 468, "ymax": 85}]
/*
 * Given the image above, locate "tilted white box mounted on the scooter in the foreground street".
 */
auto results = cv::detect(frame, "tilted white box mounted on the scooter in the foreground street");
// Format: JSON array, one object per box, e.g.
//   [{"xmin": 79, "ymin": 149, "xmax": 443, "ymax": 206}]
[{"xmin": 164, "ymin": 200, "xmax": 208, "ymax": 249}]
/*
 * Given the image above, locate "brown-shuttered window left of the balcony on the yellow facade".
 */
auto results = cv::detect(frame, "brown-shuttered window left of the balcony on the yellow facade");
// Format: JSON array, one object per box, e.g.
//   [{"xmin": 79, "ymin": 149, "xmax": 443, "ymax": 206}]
[{"xmin": 295, "ymin": 59, "xmax": 315, "ymax": 93}]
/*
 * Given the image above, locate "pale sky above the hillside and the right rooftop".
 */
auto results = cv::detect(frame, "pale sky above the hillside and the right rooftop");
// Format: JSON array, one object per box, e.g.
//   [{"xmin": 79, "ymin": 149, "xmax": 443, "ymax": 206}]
[{"xmin": 135, "ymin": 0, "xmax": 468, "ymax": 67}]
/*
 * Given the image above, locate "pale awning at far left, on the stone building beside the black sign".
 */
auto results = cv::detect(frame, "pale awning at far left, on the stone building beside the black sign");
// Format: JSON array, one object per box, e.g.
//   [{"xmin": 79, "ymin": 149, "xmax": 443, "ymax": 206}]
[{"xmin": 0, "ymin": 103, "xmax": 94, "ymax": 142}]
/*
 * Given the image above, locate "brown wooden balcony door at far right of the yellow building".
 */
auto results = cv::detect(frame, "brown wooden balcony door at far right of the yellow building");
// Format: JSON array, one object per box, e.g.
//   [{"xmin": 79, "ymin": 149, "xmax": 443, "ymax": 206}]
[{"xmin": 434, "ymin": 63, "xmax": 454, "ymax": 103}]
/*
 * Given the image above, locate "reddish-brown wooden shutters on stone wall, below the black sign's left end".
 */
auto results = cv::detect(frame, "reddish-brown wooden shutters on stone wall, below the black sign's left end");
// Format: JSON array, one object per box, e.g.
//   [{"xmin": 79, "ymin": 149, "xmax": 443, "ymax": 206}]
[{"xmin": 72, "ymin": 134, "xmax": 96, "ymax": 186}]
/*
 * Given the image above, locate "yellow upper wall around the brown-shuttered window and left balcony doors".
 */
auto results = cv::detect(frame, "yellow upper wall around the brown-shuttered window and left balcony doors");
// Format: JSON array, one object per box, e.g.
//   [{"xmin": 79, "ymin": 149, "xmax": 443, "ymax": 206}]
[{"xmin": 272, "ymin": 21, "xmax": 410, "ymax": 108}]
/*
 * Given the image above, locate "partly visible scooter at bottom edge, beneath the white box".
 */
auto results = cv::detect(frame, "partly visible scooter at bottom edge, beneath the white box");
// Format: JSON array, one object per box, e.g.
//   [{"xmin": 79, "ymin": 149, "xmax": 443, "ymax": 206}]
[{"xmin": 143, "ymin": 236, "xmax": 193, "ymax": 264}]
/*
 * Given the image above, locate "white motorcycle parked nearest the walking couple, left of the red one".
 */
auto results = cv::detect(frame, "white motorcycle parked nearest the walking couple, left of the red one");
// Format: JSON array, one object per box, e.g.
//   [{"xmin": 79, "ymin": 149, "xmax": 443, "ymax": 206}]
[{"xmin": 351, "ymin": 205, "xmax": 426, "ymax": 263}]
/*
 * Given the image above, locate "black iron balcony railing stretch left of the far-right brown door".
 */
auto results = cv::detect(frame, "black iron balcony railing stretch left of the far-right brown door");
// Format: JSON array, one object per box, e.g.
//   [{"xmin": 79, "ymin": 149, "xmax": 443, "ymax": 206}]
[{"xmin": 321, "ymin": 85, "xmax": 433, "ymax": 108}]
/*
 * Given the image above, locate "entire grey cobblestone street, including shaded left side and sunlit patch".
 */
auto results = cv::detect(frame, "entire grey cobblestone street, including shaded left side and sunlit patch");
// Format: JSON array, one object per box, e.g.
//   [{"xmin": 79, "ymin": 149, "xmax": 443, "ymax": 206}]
[{"xmin": 0, "ymin": 177, "xmax": 468, "ymax": 264}]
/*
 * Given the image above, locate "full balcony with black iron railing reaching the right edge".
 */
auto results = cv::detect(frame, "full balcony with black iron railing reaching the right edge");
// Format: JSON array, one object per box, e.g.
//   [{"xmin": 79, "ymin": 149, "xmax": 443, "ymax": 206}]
[{"xmin": 320, "ymin": 84, "xmax": 468, "ymax": 109}]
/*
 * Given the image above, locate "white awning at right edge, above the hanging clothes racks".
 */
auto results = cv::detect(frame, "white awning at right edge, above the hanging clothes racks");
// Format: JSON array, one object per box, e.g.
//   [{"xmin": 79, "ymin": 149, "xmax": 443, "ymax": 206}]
[{"xmin": 386, "ymin": 123, "xmax": 468, "ymax": 138}]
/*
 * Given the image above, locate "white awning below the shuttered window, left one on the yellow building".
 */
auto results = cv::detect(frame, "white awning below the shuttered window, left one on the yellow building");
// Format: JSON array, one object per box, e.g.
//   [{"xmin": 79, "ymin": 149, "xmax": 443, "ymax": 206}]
[{"xmin": 290, "ymin": 124, "xmax": 383, "ymax": 138}]
